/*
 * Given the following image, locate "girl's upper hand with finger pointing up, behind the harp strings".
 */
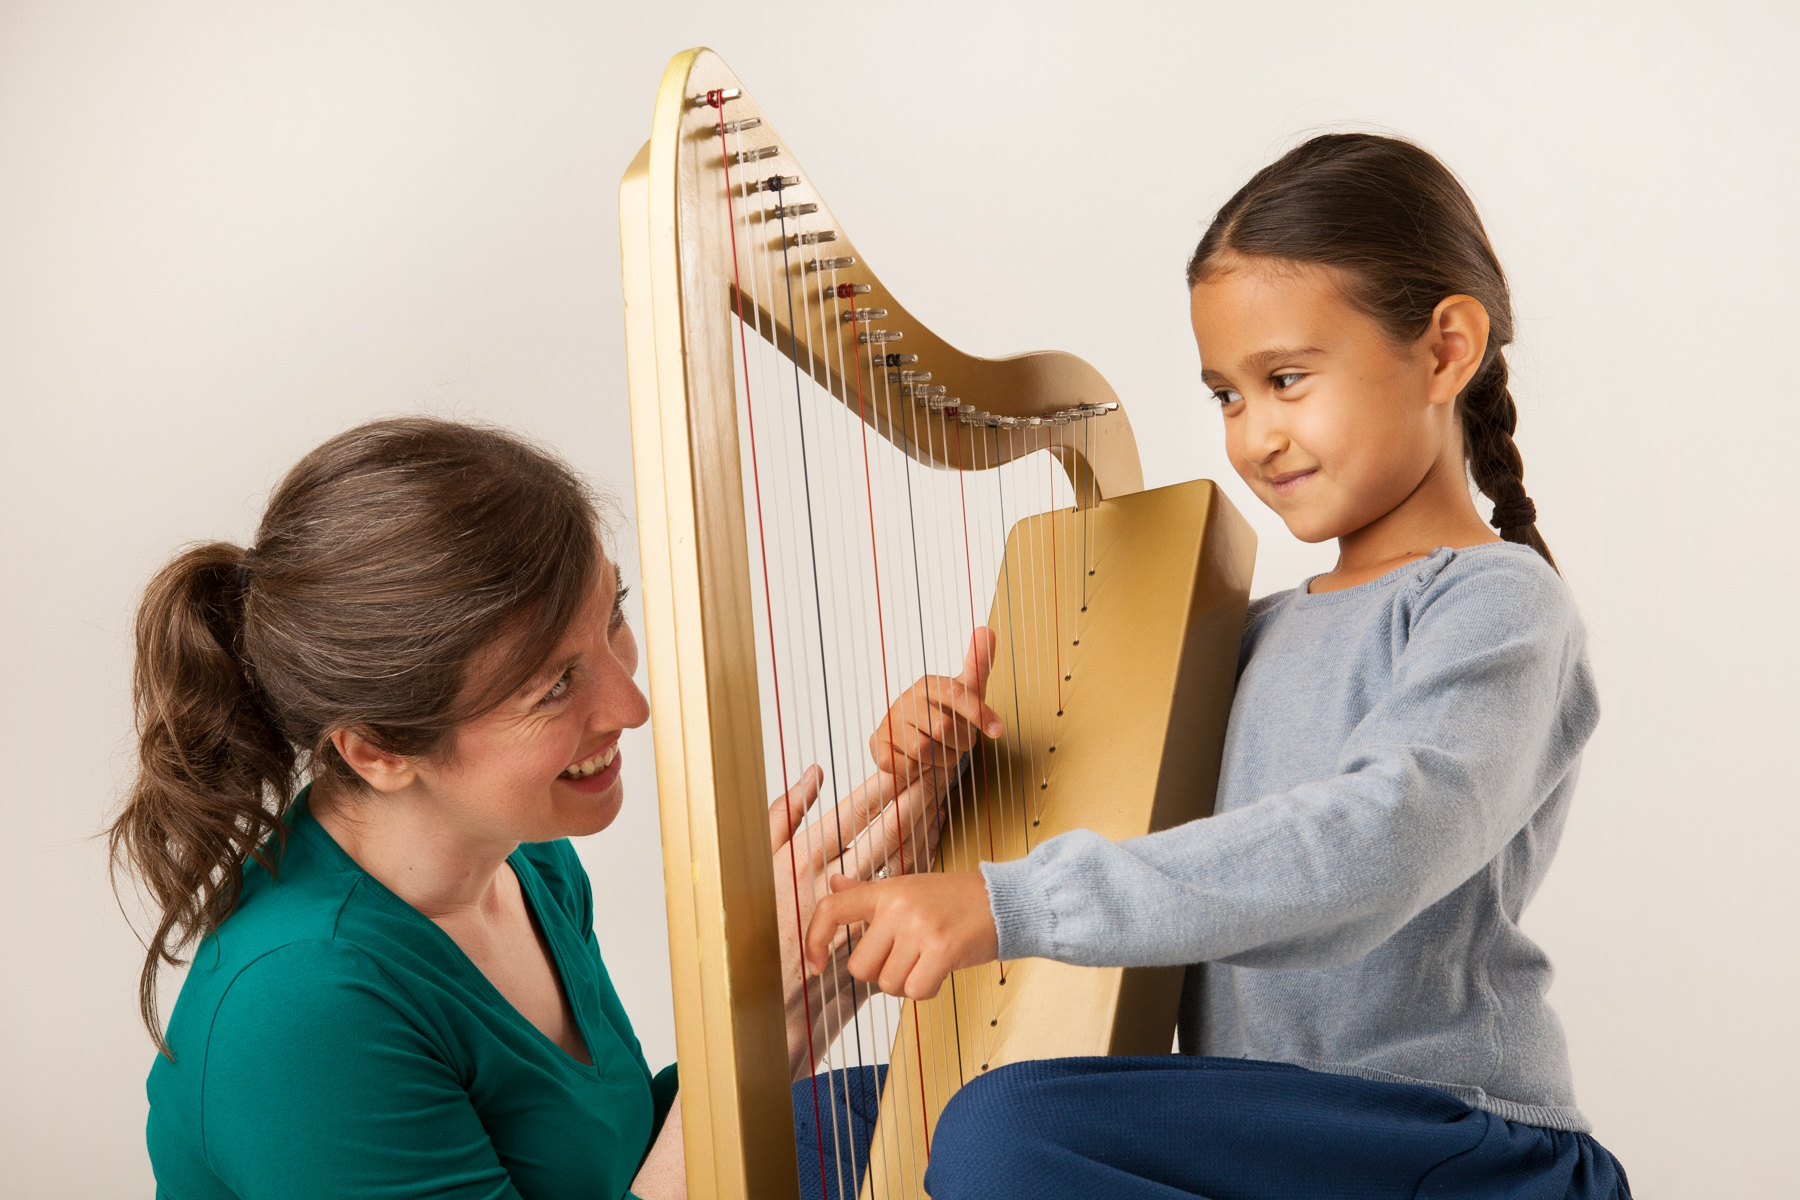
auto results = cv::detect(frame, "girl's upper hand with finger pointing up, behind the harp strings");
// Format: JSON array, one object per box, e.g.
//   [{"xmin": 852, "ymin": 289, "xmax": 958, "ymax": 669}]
[{"xmin": 869, "ymin": 628, "xmax": 1006, "ymax": 786}]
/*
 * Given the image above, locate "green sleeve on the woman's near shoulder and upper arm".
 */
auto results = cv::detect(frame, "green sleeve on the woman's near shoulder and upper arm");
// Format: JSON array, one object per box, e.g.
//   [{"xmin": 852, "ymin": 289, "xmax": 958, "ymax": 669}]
[{"xmin": 200, "ymin": 941, "xmax": 520, "ymax": 1200}]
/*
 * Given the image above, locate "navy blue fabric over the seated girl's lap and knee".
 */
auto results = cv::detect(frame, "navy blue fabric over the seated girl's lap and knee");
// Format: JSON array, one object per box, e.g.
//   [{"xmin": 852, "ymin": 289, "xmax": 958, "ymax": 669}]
[{"xmin": 921, "ymin": 1054, "xmax": 1631, "ymax": 1200}]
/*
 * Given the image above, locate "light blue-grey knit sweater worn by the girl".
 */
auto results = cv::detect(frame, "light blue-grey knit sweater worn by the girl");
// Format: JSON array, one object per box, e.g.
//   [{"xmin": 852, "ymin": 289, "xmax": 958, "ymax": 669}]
[{"xmin": 983, "ymin": 542, "xmax": 1600, "ymax": 1132}]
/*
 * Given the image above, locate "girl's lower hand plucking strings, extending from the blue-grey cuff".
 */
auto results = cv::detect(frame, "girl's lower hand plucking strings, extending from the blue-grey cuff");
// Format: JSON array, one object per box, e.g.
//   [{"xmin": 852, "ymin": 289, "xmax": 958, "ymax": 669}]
[{"xmin": 805, "ymin": 871, "xmax": 999, "ymax": 1000}]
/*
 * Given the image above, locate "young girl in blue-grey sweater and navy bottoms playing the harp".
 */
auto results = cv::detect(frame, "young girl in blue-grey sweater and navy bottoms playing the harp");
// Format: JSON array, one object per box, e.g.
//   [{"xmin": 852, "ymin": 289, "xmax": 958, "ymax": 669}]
[{"xmin": 808, "ymin": 133, "xmax": 1629, "ymax": 1200}]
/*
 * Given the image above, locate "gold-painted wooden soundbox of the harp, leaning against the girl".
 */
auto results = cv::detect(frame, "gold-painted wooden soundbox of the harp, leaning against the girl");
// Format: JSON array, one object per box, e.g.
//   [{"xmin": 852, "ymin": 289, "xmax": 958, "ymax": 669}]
[{"xmin": 862, "ymin": 480, "xmax": 1255, "ymax": 1196}]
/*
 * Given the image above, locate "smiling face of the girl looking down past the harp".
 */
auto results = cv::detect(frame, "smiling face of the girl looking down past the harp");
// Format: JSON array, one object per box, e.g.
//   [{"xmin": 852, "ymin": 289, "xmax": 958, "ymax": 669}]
[{"xmin": 1192, "ymin": 255, "xmax": 1461, "ymax": 542}]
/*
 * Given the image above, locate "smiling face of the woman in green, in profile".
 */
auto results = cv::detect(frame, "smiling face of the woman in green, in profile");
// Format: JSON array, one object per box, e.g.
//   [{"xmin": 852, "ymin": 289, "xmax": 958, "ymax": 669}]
[{"xmin": 418, "ymin": 558, "xmax": 650, "ymax": 842}]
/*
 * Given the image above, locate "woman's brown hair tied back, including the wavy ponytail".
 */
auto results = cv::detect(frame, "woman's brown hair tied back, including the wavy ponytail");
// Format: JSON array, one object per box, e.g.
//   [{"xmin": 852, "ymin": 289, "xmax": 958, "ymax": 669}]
[{"xmin": 108, "ymin": 417, "xmax": 603, "ymax": 1054}]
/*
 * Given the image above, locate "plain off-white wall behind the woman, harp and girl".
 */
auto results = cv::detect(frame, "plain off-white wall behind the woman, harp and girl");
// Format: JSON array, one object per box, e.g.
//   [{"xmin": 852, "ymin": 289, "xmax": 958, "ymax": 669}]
[{"xmin": 0, "ymin": 0, "xmax": 1800, "ymax": 1198}]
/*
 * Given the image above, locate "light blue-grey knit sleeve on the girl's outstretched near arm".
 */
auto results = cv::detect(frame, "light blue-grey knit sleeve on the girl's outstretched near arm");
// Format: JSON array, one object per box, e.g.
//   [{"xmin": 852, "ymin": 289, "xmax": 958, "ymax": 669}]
[{"xmin": 981, "ymin": 557, "xmax": 1598, "ymax": 968}]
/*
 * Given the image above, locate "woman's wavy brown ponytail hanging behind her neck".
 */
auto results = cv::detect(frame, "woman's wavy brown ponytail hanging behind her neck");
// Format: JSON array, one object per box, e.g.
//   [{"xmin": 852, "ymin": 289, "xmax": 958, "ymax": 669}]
[{"xmin": 108, "ymin": 542, "xmax": 295, "ymax": 1054}]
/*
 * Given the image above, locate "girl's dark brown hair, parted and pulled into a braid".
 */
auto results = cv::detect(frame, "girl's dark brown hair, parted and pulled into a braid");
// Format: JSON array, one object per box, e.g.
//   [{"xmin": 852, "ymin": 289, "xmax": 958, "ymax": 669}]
[{"xmin": 1188, "ymin": 133, "xmax": 1557, "ymax": 567}]
